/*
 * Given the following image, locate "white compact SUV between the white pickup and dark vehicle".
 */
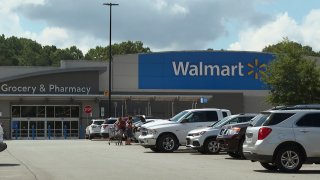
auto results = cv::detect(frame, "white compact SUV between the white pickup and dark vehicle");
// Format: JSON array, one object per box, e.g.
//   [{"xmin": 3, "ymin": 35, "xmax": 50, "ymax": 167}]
[{"xmin": 186, "ymin": 113, "xmax": 257, "ymax": 154}]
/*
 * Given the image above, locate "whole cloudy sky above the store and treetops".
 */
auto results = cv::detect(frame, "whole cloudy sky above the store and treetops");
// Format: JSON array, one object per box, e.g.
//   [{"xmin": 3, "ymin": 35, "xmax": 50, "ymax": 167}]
[{"xmin": 0, "ymin": 0, "xmax": 320, "ymax": 53}]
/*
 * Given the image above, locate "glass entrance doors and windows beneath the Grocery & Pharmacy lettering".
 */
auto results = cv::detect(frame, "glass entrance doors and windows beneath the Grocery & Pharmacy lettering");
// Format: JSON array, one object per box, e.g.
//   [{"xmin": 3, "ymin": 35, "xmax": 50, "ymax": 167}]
[{"xmin": 11, "ymin": 105, "xmax": 80, "ymax": 139}]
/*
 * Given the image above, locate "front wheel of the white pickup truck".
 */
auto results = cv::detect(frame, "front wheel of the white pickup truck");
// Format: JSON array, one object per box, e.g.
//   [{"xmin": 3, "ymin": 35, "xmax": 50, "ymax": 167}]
[{"xmin": 157, "ymin": 134, "xmax": 179, "ymax": 152}]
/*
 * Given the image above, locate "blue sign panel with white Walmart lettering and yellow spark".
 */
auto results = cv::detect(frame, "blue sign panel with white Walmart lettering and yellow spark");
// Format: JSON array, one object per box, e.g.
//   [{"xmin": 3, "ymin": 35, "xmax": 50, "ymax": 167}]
[{"xmin": 139, "ymin": 51, "xmax": 274, "ymax": 90}]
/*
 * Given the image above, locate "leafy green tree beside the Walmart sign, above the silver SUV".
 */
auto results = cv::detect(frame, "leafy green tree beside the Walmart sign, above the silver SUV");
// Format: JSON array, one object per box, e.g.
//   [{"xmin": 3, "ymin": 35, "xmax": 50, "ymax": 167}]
[{"xmin": 263, "ymin": 39, "xmax": 320, "ymax": 105}]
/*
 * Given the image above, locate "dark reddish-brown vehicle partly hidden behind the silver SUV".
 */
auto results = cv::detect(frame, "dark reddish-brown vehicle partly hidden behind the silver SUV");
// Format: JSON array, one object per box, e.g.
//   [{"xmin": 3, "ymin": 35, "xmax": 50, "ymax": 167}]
[{"xmin": 217, "ymin": 115, "xmax": 263, "ymax": 159}]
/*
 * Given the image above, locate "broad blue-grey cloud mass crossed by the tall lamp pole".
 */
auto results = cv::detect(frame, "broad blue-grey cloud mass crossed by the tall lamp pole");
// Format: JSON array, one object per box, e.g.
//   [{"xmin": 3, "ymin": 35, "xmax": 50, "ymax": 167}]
[{"xmin": 13, "ymin": 0, "xmax": 269, "ymax": 51}]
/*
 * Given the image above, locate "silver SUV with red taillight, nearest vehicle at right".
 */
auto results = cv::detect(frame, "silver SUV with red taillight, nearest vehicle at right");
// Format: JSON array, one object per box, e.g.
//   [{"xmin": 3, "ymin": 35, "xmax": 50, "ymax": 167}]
[{"xmin": 243, "ymin": 108, "xmax": 320, "ymax": 172}]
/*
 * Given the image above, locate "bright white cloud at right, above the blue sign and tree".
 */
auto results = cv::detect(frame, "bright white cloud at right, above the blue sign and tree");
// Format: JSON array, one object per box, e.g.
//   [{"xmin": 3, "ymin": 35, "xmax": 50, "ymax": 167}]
[{"xmin": 229, "ymin": 10, "xmax": 320, "ymax": 51}]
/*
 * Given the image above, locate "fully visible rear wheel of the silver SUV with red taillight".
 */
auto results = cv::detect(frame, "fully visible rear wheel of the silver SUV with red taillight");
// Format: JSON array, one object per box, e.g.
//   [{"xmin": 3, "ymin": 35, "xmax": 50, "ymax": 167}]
[{"xmin": 275, "ymin": 146, "xmax": 303, "ymax": 173}]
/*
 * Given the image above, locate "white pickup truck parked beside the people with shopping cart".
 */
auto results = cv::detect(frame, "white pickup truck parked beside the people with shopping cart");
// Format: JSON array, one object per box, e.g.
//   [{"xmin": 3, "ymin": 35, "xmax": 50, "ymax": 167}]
[{"xmin": 139, "ymin": 108, "xmax": 231, "ymax": 152}]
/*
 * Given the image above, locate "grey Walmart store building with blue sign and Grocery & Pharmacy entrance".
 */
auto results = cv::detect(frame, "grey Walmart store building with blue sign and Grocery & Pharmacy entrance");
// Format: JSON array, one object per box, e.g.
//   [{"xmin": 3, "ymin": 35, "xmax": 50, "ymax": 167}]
[{"xmin": 0, "ymin": 51, "xmax": 274, "ymax": 139}]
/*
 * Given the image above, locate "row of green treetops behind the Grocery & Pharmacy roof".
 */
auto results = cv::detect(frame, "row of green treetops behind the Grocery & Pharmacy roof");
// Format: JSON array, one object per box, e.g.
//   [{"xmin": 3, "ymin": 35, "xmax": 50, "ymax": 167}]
[{"xmin": 0, "ymin": 35, "xmax": 151, "ymax": 66}]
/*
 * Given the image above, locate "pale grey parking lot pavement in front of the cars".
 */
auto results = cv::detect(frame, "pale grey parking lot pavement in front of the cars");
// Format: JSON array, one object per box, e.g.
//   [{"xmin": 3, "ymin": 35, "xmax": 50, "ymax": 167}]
[{"xmin": 0, "ymin": 140, "xmax": 320, "ymax": 180}]
